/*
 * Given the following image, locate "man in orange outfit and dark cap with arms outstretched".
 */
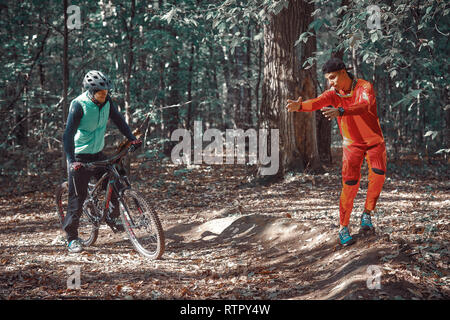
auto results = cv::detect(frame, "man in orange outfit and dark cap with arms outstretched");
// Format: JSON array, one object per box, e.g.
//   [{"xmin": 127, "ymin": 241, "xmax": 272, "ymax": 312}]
[{"xmin": 286, "ymin": 58, "xmax": 386, "ymax": 245}]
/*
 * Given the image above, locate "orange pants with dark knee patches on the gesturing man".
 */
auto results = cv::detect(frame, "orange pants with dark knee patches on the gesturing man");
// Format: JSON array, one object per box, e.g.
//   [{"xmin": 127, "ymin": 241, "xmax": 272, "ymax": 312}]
[{"xmin": 339, "ymin": 142, "xmax": 386, "ymax": 226}]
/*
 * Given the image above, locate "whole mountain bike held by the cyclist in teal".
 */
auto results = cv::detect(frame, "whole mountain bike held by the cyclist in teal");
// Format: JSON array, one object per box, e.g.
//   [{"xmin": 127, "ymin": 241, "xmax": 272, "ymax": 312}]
[{"xmin": 56, "ymin": 140, "xmax": 165, "ymax": 259}]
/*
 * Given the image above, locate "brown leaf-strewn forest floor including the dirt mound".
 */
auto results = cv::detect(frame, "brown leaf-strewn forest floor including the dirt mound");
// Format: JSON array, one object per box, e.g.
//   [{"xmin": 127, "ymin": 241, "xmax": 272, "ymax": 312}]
[{"xmin": 0, "ymin": 148, "xmax": 450, "ymax": 300}]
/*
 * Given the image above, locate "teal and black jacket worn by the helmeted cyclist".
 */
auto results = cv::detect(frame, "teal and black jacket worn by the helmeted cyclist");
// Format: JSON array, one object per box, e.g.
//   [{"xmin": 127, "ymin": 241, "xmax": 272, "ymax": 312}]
[{"xmin": 63, "ymin": 91, "xmax": 136, "ymax": 163}]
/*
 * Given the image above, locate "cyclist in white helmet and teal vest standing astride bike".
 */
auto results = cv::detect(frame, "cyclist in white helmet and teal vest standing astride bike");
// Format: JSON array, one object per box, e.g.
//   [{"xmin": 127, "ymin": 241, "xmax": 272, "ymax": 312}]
[{"xmin": 63, "ymin": 70, "xmax": 141, "ymax": 252}]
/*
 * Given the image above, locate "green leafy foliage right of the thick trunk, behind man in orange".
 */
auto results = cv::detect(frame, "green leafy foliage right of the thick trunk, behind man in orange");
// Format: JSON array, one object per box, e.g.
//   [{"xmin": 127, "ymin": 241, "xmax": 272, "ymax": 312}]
[{"xmin": 297, "ymin": 0, "xmax": 450, "ymax": 151}]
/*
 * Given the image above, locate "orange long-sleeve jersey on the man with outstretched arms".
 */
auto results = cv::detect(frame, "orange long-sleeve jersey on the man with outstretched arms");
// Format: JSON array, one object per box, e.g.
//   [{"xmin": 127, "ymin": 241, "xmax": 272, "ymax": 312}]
[{"xmin": 300, "ymin": 79, "xmax": 384, "ymax": 146}]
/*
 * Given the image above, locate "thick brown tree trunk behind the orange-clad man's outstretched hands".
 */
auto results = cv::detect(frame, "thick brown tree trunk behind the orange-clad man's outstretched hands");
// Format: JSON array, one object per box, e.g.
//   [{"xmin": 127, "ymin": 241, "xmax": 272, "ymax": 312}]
[{"xmin": 261, "ymin": 0, "xmax": 320, "ymax": 176}]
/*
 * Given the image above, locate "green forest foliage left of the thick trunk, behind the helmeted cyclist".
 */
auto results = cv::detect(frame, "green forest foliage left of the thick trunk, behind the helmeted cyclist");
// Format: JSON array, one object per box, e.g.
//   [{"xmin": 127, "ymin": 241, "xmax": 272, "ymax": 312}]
[{"xmin": 0, "ymin": 0, "xmax": 266, "ymax": 174}]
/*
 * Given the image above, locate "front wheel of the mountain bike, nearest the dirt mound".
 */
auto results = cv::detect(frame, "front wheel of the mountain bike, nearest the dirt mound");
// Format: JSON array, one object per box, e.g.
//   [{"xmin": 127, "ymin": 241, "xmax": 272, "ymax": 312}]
[{"xmin": 120, "ymin": 189, "xmax": 165, "ymax": 259}]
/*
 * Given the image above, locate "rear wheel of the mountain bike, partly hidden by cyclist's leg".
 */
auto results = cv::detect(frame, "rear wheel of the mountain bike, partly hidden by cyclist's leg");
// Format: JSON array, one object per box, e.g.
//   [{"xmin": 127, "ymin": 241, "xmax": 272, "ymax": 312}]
[{"xmin": 55, "ymin": 181, "xmax": 98, "ymax": 247}]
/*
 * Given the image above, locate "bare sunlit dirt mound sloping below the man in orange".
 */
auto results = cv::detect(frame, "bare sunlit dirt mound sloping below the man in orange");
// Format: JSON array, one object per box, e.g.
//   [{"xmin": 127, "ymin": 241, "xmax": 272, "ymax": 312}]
[{"xmin": 168, "ymin": 214, "xmax": 408, "ymax": 299}]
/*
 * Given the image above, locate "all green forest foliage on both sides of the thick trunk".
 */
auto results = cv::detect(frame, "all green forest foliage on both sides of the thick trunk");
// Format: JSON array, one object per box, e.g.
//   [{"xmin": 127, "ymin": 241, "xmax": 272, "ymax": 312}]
[{"xmin": 0, "ymin": 0, "xmax": 450, "ymax": 181}]
